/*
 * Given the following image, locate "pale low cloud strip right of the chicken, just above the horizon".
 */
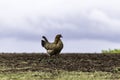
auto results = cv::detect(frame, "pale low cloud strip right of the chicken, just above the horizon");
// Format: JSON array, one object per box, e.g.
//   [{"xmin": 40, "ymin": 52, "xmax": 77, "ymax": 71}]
[{"xmin": 63, "ymin": 39, "xmax": 120, "ymax": 53}]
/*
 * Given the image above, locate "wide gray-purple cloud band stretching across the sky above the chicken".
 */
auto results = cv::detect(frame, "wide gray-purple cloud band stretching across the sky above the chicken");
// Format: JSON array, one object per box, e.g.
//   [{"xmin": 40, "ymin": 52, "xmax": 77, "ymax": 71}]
[{"xmin": 0, "ymin": 15, "xmax": 120, "ymax": 42}]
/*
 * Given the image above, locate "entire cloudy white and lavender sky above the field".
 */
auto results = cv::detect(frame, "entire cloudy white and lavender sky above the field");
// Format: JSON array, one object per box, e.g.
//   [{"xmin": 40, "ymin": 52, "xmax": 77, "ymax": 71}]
[{"xmin": 0, "ymin": 0, "xmax": 120, "ymax": 53}]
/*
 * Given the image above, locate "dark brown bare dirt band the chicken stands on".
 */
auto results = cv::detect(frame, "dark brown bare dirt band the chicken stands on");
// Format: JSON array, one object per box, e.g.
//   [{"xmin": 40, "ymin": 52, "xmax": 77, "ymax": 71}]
[{"xmin": 0, "ymin": 53, "xmax": 120, "ymax": 72}]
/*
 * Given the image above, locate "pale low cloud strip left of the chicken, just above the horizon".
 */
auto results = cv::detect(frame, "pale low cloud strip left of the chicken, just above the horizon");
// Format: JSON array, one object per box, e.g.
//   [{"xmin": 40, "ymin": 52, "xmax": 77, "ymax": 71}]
[{"xmin": 0, "ymin": 38, "xmax": 41, "ymax": 53}]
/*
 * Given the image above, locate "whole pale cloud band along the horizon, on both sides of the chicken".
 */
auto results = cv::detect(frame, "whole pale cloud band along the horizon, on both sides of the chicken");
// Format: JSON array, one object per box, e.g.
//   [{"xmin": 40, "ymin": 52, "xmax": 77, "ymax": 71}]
[{"xmin": 0, "ymin": 38, "xmax": 120, "ymax": 53}]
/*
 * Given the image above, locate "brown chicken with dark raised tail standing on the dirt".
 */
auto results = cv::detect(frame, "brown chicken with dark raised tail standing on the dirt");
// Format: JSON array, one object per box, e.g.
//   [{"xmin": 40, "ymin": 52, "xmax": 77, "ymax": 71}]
[{"xmin": 41, "ymin": 34, "xmax": 63, "ymax": 56}]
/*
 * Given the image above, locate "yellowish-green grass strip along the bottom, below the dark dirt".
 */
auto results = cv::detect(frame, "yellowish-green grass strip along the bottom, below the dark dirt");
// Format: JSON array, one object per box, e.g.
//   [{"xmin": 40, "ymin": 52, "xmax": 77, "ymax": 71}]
[{"xmin": 0, "ymin": 70, "xmax": 120, "ymax": 80}]
